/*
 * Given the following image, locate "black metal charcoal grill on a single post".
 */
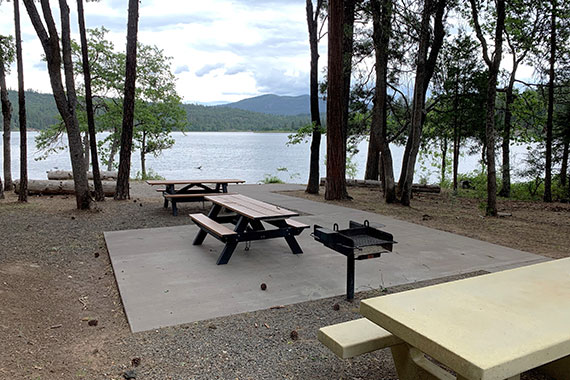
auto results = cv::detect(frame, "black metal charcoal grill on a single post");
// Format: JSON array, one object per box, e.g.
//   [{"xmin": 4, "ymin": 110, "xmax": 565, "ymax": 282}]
[{"xmin": 312, "ymin": 220, "xmax": 396, "ymax": 300}]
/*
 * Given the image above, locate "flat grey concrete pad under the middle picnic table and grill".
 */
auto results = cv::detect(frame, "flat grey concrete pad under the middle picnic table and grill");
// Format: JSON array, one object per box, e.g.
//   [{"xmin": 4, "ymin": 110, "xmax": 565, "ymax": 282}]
[{"xmin": 105, "ymin": 185, "xmax": 546, "ymax": 332}]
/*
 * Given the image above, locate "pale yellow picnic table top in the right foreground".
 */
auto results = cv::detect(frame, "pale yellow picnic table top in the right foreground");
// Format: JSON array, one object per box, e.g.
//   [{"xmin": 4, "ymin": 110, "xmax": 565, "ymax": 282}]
[{"xmin": 360, "ymin": 258, "xmax": 570, "ymax": 380}]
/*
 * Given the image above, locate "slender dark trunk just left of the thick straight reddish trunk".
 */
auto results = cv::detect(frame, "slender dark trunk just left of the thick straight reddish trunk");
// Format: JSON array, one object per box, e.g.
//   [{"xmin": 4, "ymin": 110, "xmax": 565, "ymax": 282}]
[{"xmin": 305, "ymin": 0, "xmax": 323, "ymax": 194}]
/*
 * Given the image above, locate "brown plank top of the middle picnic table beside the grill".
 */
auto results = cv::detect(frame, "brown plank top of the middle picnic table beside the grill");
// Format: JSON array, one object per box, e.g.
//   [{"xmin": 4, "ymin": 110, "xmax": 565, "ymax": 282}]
[{"xmin": 204, "ymin": 194, "xmax": 299, "ymax": 220}]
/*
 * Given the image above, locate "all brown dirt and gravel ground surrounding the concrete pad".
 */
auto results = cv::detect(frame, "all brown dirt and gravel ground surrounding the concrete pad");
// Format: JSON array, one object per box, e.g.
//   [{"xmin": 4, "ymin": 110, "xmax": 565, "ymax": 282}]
[{"xmin": 0, "ymin": 183, "xmax": 560, "ymax": 380}]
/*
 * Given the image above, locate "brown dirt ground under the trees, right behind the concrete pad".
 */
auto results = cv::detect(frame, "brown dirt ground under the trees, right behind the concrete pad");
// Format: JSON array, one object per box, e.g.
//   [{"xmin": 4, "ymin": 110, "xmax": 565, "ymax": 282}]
[{"xmin": 284, "ymin": 187, "xmax": 570, "ymax": 259}]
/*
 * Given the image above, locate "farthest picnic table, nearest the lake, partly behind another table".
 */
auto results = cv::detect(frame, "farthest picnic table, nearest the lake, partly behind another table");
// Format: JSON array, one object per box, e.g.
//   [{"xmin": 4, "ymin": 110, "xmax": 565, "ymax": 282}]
[{"xmin": 146, "ymin": 179, "xmax": 245, "ymax": 216}]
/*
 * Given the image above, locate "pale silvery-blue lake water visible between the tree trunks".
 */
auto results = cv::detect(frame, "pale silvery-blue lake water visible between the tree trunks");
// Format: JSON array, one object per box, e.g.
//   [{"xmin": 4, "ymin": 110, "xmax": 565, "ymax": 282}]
[{"xmin": 0, "ymin": 132, "xmax": 524, "ymax": 183}]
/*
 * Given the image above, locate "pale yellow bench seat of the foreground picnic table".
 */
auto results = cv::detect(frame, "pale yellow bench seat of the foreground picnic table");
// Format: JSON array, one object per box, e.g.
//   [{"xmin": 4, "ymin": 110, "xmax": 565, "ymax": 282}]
[{"xmin": 317, "ymin": 318, "xmax": 402, "ymax": 359}]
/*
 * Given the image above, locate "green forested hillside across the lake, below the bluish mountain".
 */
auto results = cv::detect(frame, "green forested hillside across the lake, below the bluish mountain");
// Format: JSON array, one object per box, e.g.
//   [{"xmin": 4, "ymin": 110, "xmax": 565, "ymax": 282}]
[{"xmin": 9, "ymin": 91, "xmax": 310, "ymax": 132}]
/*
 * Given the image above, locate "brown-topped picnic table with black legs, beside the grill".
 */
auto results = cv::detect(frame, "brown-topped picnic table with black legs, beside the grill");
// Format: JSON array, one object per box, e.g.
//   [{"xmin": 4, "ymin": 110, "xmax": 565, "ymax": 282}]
[{"xmin": 190, "ymin": 194, "xmax": 309, "ymax": 265}]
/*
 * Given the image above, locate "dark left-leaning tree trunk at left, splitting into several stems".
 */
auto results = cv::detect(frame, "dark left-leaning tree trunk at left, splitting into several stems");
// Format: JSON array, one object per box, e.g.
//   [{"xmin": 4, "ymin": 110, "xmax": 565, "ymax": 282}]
[{"xmin": 24, "ymin": 0, "xmax": 91, "ymax": 210}]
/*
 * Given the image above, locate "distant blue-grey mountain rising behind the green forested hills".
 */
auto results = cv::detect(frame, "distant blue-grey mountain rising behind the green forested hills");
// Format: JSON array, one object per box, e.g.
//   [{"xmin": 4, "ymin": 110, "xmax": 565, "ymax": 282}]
[{"xmin": 218, "ymin": 94, "xmax": 326, "ymax": 116}]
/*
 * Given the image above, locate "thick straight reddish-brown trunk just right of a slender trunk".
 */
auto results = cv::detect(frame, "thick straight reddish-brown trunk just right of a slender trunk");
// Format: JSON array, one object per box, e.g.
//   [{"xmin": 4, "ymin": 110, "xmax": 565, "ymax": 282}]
[{"xmin": 325, "ymin": 0, "xmax": 346, "ymax": 200}]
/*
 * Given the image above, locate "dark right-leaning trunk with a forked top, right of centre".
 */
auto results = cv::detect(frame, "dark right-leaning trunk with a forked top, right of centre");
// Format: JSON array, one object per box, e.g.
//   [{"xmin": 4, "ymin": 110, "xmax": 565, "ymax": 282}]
[{"xmin": 400, "ymin": 0, "xmax": 446, "ymax": 206}]
